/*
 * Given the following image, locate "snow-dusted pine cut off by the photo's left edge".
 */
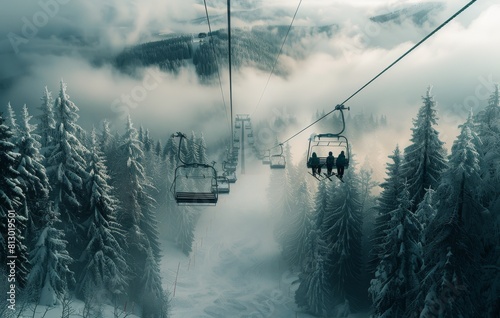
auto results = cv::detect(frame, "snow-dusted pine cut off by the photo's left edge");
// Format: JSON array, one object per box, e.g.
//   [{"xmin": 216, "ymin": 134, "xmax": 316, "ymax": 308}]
[{"xmin": 0, "ymin": 114, "xmax": 29, "ymax": 288}]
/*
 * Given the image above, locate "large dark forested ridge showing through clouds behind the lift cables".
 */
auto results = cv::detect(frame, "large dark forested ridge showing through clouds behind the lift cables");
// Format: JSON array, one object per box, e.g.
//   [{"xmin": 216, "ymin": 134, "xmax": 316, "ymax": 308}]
[{"xmin": 114, "ymin": 25, "xmax": 338, "ymax": 78}]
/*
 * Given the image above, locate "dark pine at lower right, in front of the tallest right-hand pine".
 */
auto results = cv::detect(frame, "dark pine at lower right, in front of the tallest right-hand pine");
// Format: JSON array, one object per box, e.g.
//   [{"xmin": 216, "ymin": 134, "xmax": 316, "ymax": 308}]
[{"xmin": 368, "ymin": 183, "xmax": 422, "ymax": 317}]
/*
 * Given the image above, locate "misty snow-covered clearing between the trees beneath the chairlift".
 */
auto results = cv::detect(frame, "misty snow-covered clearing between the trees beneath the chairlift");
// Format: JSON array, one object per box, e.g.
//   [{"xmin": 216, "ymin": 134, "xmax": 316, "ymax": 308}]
[{"xmin": 162, "ymin": 168, "xmax": 312, "ymax": 318}]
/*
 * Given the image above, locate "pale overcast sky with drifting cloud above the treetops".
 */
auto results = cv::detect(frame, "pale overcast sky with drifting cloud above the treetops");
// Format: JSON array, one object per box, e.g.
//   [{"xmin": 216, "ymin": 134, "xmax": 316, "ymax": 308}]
[{"xmin": 0, "ymin": 0, "xmax": 500, "ymax": 168}]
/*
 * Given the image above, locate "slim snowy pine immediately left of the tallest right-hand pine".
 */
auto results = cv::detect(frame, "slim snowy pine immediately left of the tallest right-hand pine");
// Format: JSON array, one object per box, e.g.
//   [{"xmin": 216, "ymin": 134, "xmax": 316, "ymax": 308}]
[{"xmin": 368, "ymin": 146, "xmax": 404, "ymax": 273}]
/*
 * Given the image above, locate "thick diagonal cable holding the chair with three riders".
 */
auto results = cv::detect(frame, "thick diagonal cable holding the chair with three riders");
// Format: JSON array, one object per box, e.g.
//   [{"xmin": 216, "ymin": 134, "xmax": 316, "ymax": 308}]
[{"xmin": 270, "ymin": 0, "xmax": 477, "ymax": 149}]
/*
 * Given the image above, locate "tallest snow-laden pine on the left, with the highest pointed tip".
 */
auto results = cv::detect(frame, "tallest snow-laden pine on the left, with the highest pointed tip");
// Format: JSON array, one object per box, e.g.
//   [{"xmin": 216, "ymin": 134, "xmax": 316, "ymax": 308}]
[{"xmin": 46, "ymin": 80, "xmax": 88, "ymax": 258}]
